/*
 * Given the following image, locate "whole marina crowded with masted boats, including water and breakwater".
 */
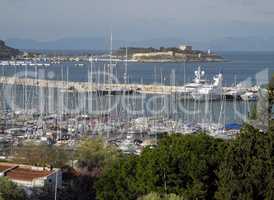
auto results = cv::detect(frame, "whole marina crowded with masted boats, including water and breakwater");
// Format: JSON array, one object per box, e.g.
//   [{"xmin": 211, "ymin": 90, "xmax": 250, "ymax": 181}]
[{"xmin": 0, "ymin": 59, "xmax": 261, "ymax": 156}]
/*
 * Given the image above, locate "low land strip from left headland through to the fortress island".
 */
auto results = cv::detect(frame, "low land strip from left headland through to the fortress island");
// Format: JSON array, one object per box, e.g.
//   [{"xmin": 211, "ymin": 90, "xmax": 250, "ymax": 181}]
[{"xmin": 0, "ymin": 40, "xmax": 224, "ymax": 66}]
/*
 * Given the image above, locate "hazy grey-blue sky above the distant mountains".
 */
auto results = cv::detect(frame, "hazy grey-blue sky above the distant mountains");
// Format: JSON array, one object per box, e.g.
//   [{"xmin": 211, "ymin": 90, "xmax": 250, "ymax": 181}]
[{"xmin": 0, "ymin": 0, "xmax": 274, "ymax": 41}]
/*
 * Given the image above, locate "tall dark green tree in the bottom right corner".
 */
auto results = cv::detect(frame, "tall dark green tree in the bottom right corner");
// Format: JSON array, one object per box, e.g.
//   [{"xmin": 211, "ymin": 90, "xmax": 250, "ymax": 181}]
[{"xmin": 215, "ymin": 125, "xmax": 274, "ymax": 200}]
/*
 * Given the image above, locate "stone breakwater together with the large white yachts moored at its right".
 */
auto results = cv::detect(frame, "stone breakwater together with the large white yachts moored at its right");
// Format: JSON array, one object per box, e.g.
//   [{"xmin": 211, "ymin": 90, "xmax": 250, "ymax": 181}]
[{"xmin": 0, "ymin": 67, "xmax": 259, "ymax": 100}]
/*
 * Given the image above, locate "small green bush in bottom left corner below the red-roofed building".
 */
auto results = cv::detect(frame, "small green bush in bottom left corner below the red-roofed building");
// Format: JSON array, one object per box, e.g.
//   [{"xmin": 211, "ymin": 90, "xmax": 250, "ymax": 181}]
[{"xmin": 0, "ymin": 177, "xmax": 26, "ymax": 200}]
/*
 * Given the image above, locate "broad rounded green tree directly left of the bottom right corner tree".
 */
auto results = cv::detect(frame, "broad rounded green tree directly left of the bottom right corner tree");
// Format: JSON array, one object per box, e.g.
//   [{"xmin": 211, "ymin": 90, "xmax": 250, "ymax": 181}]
[{"xmin": 137, "ymin": 134, "xmax": 225, "ymax": 199}]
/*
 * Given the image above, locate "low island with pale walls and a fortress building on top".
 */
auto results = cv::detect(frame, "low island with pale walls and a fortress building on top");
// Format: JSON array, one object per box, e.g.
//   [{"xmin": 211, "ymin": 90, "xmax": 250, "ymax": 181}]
[{"xmin": 113, "ymin": 45, "xmax": 223, "ymax": 62}]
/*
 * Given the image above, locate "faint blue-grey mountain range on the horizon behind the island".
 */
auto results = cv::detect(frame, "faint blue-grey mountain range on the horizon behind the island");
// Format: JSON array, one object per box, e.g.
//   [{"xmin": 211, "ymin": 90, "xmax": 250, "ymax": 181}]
[{"xmin": 7, "ymin": 37, "xmax": 274, "ymax": 51}]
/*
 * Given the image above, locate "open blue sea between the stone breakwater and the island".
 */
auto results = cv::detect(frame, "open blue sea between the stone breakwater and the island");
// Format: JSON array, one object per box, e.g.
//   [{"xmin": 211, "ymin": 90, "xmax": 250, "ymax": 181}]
[{"xmin": 0, "ymin": 52, "xmax": 274, "ymax": 86}]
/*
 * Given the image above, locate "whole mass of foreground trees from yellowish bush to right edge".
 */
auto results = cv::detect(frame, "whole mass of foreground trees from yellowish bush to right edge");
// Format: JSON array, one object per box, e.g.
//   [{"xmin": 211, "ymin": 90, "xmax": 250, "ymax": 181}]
[{"xmin": 20, "ymin": 122, "xmax": 274, "ymax": 200}]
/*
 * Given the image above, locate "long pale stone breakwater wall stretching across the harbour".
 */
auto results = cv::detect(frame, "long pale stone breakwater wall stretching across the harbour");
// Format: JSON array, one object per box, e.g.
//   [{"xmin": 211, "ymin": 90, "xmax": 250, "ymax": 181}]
[{"xmin": 0, "ymin": 76, "xmax": 258, "ymax": 95}]
